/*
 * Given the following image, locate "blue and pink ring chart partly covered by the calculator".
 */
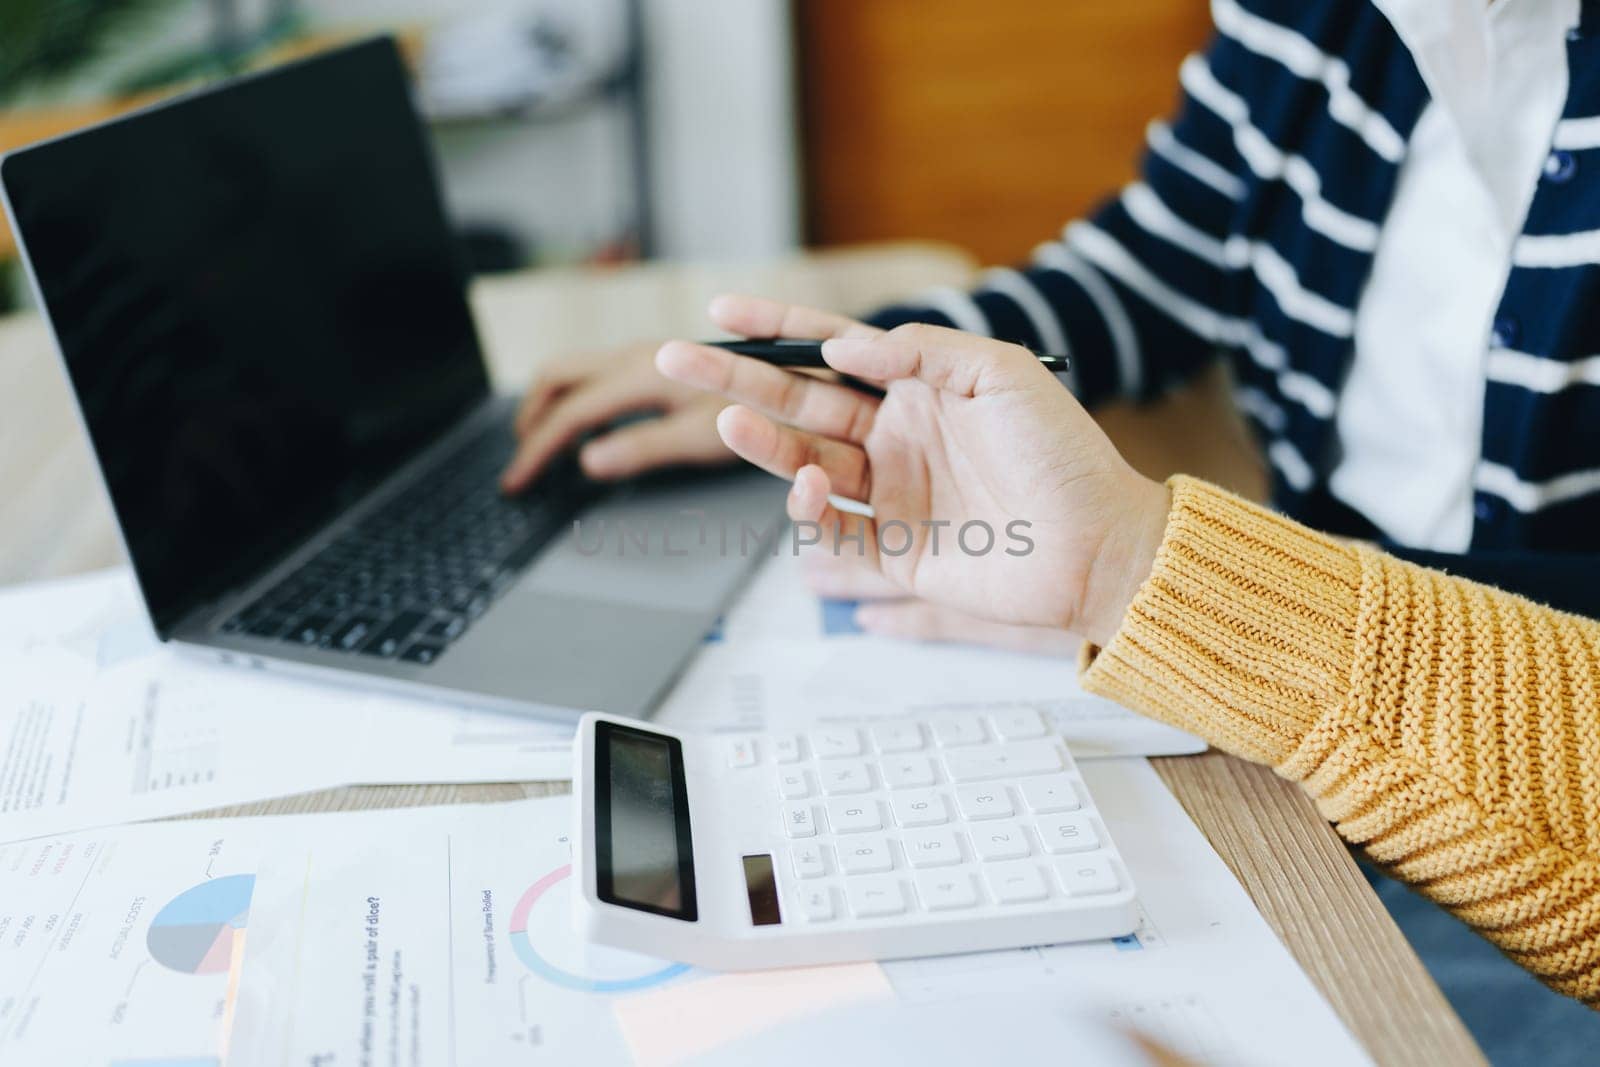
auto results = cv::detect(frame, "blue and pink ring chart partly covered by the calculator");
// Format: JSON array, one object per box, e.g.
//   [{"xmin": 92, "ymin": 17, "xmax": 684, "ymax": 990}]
[{"xmin": 507, "ymin": 864, "xmax": 690, "ymax": 993}]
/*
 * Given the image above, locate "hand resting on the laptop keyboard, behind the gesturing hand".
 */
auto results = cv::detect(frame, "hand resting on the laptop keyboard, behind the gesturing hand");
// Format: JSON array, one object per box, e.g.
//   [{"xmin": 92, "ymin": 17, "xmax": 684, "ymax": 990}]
[{"xmin": 501, "ymin": 342, "xmax": 733, "ymax": 493}]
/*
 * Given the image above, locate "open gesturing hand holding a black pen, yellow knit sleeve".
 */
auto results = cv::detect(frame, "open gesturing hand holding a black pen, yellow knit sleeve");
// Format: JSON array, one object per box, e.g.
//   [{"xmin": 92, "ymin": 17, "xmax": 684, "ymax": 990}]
[{"xmin": 656, "ymin": 299, "xmax": 1168, "ymax": 652}]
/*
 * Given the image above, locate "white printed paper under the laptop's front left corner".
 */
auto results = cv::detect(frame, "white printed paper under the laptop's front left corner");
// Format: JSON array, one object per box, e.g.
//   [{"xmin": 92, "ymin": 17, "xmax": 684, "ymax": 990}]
[{"xmin": 0, "ymin": 571, "xmax": 571, "ymax": 841}]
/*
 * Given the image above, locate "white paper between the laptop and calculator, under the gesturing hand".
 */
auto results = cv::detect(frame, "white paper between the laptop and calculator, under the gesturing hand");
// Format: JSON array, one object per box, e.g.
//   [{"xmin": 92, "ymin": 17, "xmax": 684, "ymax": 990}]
[{"xmin": 654, "ymin": 552, "xmax": 1205, "ymax": 760}]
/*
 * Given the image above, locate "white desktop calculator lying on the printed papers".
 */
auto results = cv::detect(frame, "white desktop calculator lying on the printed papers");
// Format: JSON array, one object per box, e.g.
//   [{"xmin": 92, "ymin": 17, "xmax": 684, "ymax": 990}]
[{"xmin": 573, "ymin": 709, "xmax": 1138, "ymax": 971}]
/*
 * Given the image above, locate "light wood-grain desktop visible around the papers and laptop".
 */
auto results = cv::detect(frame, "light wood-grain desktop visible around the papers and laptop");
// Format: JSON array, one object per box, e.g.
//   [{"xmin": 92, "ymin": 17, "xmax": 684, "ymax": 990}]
[{"xmin": 0, "ymin": 246, "xmax": 1485, "ymax": 1065}]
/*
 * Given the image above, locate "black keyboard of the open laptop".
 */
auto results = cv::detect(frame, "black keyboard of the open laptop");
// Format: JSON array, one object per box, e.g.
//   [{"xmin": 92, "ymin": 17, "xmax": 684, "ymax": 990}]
[{"xmin": 222, "ymin": 426, "xmax": 592, "ymax": 664}]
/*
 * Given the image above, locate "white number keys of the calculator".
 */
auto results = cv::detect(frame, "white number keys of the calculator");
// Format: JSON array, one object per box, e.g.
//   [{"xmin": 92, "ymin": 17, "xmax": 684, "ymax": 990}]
[{"xmin": 755, "ymin": 709, "xmax": 1122, "ymax": 923}]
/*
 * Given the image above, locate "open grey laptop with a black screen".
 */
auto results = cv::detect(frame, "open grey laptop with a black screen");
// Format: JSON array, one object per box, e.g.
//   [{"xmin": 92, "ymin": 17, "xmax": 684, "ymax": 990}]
[{"xmin": 0, "ymin": 38, "xmax": 782, "ymax": 715}]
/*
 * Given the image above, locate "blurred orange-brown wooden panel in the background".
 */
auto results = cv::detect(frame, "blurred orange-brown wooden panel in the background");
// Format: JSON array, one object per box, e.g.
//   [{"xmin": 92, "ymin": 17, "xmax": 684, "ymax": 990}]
[{"xmin": 795, "ymin": 0, "xmax": 1210, "ymax": 262}]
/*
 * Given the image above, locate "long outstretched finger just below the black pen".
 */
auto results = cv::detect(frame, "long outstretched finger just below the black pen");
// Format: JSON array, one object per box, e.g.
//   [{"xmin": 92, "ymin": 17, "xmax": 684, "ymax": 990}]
[{"xmin": 656, "ymin": 341, "xmax": 878, "ymax": 443}]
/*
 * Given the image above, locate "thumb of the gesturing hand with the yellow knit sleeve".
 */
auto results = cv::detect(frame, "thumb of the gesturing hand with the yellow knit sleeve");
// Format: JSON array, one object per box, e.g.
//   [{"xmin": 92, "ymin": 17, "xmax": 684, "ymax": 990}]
[{"xmin": 822, "ymin": 325, "xmax": 1050, "ymax": 397}]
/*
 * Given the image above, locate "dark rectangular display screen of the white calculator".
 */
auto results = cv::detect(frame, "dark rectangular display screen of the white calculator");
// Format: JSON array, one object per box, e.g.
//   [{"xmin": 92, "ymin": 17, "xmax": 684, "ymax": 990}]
[{"xmin": 595, "ymin": 721, "xmax": 696, "ymax": 921}]
